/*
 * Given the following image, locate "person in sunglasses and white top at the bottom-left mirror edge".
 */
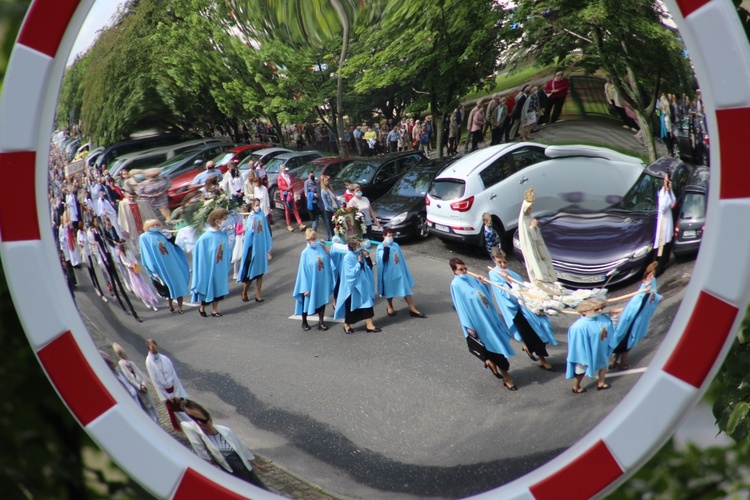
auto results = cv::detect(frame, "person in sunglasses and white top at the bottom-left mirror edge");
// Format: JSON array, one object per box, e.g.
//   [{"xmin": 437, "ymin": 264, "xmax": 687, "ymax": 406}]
[{"xmin": 181, "ymin": 399, "xmax": 268, "ymax": 490}]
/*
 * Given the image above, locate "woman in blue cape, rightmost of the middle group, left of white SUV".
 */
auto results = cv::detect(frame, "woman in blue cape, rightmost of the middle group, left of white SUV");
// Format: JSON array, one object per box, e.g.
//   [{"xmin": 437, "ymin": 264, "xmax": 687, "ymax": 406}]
[{"xmin": 375, "ymin": 227, "xmax": 427, "ymax": 318}]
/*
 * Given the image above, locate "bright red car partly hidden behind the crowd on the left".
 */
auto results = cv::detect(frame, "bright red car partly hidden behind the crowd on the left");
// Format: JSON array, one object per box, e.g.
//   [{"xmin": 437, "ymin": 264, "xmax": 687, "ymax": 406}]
[{"xmin": 162, "ymin": 144, "xmax": 267, "ymax": 209}]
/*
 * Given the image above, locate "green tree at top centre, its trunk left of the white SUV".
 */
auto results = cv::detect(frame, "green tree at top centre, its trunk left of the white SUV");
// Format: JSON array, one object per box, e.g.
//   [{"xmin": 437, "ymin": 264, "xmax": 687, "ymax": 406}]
[{"xmin": 348, "ymin": 0, "xmax": 505, "ymax": 155}]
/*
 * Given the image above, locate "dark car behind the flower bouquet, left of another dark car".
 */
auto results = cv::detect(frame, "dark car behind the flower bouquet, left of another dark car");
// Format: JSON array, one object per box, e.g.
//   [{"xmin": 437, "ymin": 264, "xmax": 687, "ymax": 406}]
[{"xmin": 331, "ymin": 151, "xmax": 427, "ymax": 203}]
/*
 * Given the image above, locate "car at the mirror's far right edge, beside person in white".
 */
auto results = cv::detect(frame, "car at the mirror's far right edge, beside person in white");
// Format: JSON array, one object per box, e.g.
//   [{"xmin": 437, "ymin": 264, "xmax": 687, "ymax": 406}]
[{"xmin": 672, "ymin": 167, "xmax": 710, "ymax": 257}]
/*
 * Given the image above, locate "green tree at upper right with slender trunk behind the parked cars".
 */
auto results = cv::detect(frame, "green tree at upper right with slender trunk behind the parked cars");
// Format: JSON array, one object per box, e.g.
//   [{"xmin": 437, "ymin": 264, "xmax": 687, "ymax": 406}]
[{"xmin": 513, "ymin": 0, "xmax": 694, "ymax": 161}]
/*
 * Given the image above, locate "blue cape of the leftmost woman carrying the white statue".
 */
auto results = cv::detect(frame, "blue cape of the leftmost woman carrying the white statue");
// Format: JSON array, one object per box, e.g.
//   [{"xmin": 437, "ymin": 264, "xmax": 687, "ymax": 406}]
[{"xmin": 451, "ymin": 275, "xmax": 516, "ymax": 358}]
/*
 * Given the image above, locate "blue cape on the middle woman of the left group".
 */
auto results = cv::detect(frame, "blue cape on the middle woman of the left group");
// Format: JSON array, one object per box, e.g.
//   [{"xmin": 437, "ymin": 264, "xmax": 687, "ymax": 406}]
[{"xmin": 190, "ymin": 229, "xmax": 232, "ymax": 302}]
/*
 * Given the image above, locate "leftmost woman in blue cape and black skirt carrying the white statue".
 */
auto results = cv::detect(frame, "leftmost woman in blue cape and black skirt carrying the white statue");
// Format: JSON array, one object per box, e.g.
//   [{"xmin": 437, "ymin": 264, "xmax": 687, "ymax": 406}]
[{"xmin": 450, "ymin": 257, "xmax": 518, "ymax": 391}]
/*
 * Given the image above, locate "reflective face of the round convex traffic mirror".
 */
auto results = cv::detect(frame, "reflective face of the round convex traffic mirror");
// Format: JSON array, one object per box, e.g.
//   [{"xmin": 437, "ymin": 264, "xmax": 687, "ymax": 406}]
[{"xmin": 49, "ymin": 0, "xmax": 710, "ymax": 497}]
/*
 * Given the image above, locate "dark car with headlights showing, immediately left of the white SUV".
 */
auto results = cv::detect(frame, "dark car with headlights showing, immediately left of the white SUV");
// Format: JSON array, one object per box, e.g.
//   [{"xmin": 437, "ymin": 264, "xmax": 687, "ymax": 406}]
[{"xmin": 372, "ymin": 158, "xmax": 455, "ymax": 239}]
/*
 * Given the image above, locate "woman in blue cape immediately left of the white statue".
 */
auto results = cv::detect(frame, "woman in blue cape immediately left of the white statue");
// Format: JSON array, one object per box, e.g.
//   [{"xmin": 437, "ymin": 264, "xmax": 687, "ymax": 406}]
[{"xmin": 490, "ymin": 247, "xmax": 557, "ymax": 372}]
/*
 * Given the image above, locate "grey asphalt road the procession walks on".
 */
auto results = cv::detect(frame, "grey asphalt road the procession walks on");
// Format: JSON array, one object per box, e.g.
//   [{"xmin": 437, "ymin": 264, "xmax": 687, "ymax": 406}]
[{"xmin": 76, "ymin": 223, "xmax": 693, "ymax": 498}]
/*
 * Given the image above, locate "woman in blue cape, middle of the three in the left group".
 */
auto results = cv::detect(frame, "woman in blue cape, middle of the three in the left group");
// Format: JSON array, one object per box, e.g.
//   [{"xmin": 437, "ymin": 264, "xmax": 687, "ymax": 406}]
[{"xmin": 190, "ymin": 208, "xmax": 232, "ymax": 318}]
